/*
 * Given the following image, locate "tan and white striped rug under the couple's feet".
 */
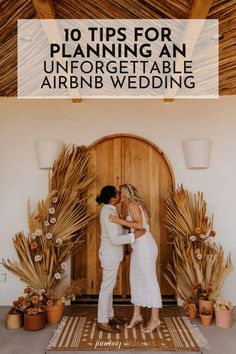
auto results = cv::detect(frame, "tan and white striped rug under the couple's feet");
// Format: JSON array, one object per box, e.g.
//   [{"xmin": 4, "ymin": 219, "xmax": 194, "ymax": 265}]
[{"xmin": 47, "ymin": 316, "xmax": 207, "ymax": 353}]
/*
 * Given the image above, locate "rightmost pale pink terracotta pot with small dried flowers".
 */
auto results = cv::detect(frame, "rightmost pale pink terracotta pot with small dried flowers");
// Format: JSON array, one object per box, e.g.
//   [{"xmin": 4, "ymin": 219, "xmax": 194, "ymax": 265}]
[{"xmin": 214, "ymin": 298, "xmax": 233, "ymax": 328}]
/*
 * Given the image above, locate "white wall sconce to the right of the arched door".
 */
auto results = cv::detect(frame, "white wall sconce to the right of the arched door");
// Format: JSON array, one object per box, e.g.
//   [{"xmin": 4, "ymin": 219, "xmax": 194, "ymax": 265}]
[{"xmin": 183, "ymin": 139, "xmax": 211, "ymax": 169}]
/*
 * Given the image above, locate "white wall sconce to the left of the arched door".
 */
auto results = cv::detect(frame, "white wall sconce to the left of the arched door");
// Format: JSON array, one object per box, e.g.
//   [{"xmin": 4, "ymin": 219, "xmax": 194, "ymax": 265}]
[{"xmin": 35, "ymin": 139, "xmax": 65, "ymax": 169}]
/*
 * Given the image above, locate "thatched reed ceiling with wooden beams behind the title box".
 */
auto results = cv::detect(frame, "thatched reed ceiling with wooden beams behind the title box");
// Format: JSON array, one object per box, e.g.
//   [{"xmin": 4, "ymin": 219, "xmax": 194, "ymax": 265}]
[{"xmin": 0, "ymin": 0, "xmax": 236, "ymax": 96}]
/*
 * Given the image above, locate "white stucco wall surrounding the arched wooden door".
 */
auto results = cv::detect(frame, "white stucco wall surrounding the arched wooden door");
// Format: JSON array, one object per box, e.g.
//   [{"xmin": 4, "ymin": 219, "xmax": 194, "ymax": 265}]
[{"xmin": 0, "ymin": 96, "xmax": 236, "ymax": 305}]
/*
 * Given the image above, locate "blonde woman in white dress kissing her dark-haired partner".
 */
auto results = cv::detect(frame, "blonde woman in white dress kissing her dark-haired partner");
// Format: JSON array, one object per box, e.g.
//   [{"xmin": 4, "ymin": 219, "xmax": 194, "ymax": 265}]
[{"xmin": 110, "ymin": 184, "xmax": 162, "ymax": 333}]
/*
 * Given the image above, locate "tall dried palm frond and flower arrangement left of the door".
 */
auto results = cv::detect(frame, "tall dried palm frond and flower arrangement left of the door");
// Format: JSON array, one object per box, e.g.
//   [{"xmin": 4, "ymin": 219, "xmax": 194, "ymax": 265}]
[{"xmin": 2, "ymin": 145, "xmax": 94, "ymax": 300}]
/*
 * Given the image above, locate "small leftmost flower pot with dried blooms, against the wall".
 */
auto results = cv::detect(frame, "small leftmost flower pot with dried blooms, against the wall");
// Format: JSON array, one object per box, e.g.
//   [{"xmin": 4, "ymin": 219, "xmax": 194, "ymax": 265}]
[{"xmin": 6, "ymin": 296, "xmax": 24, "ymax": 329}]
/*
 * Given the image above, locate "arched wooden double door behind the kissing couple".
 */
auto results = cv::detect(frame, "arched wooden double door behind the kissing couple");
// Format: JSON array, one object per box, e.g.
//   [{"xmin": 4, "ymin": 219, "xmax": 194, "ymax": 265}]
[{"xmin": 72, "ymin": 134, "xmax": 174, "ymax": 296}]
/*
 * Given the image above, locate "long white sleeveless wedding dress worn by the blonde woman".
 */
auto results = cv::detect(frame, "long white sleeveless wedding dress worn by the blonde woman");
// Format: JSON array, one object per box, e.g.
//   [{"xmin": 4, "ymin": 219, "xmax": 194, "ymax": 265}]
[{"xmin": 127, "ymin": 206, "xmax": 162, "ymax": 308}]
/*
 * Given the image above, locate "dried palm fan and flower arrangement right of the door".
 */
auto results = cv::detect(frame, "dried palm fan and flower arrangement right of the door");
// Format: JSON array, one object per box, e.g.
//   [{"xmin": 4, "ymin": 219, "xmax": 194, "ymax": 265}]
[{"xmin": 164, "ymin": 185, "xmax": 233, "ymax": 303}]
